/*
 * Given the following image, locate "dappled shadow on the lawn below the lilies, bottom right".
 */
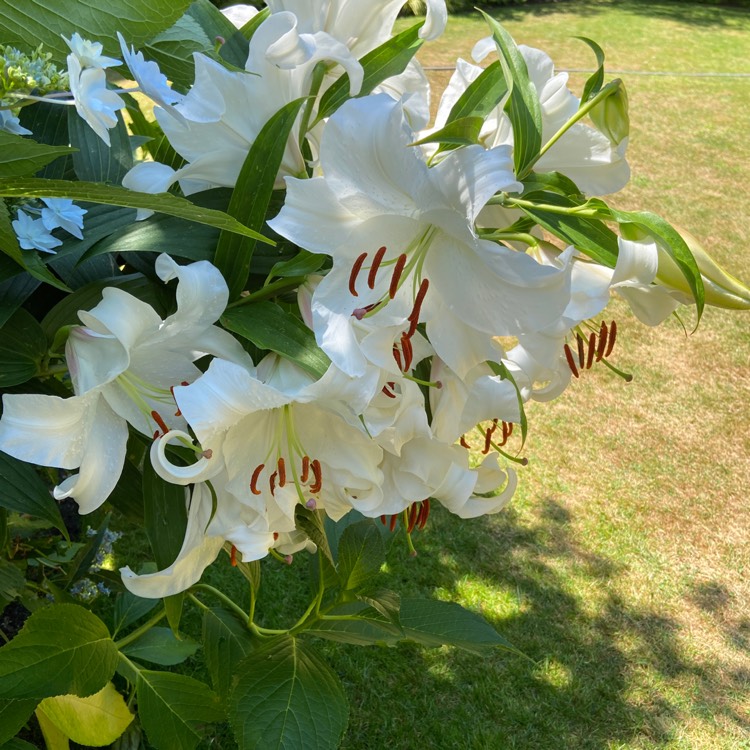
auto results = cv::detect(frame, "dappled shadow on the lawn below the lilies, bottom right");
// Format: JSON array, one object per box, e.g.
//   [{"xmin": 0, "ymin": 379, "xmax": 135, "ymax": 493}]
[{"xmin": 323, "ymin": 499, "xmax": 750, "ymax": 750}]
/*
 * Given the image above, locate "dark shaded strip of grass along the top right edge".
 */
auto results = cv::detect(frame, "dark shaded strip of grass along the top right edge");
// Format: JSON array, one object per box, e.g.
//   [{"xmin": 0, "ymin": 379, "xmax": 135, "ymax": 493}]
[{"xmin": 468, "ymin": 0, "xmax": 748, "ymax": 26}]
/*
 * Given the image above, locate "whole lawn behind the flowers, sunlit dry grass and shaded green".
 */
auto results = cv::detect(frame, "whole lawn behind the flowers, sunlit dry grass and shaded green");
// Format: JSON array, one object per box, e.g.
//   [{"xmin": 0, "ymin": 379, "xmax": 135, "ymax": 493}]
[{"xmin": 141, "ymin": 2, "xmax": 750, "ymax": 750}]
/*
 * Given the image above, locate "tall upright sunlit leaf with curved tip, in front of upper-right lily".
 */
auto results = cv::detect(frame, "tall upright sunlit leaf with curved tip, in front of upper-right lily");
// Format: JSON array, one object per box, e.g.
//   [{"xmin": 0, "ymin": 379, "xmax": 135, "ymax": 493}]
[{"xmin": 480, "ymin": 11, "xmax": 542, "ymax": 178}]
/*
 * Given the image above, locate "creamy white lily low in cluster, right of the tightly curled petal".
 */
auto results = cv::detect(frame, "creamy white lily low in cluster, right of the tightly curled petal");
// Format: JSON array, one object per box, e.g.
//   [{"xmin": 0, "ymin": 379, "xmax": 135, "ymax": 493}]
[{"xmin": 167, "ymin": 355, "xmax": 382, "ymax": 531}]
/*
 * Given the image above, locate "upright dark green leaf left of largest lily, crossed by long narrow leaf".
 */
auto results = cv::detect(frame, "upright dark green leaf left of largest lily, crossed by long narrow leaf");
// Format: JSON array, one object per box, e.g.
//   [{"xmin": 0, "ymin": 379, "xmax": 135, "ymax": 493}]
[{"xmin": 214, "ymin": 99, "xmax": 306, "ymax": 299}]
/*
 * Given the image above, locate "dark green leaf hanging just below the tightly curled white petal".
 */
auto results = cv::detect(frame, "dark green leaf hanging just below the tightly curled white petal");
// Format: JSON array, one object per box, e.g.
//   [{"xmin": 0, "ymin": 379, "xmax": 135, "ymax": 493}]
[{"xmin": 143, "ymin": 461, "xmax": 187, "ymax": 570}]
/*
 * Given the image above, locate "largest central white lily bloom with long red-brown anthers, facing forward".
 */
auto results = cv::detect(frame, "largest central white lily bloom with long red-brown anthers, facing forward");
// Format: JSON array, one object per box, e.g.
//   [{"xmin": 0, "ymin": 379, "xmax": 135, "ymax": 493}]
[{"xmin": 269, "ymin": 95, "xmax": 569, "ymax": 382}]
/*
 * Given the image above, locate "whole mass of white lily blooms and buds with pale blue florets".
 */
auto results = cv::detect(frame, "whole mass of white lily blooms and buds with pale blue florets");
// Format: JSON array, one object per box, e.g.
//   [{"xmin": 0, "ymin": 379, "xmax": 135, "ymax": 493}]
[{"xmin": 0, "ymin": 0, "xmax": 750, "ymax": 597}]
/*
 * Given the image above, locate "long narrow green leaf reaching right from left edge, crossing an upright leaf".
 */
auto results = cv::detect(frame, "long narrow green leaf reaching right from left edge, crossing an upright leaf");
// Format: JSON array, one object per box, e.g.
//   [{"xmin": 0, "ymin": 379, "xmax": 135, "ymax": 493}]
[{"xmin": 0, "ymin": 178, "xmax": 273, "ymax": 244}]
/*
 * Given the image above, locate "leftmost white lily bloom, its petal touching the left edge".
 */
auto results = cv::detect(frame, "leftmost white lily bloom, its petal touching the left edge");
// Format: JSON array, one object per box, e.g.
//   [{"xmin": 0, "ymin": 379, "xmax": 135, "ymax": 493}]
[{"xmin": 0, "ymin": 255, "xmax": 248, "ymax": 513}]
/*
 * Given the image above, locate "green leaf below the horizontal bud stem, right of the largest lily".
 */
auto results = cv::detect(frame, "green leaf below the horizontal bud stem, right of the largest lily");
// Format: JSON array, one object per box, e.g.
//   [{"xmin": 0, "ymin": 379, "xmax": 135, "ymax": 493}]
[{"xmin": 521, "ymin": 192, "xmax": 619, "ymax": 268}]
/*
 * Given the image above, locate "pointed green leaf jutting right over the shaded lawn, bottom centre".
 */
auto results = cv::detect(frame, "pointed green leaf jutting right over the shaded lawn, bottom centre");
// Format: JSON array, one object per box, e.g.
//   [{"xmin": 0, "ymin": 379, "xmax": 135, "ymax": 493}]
[{"xmin": 400, "ymin": 599, "xmax": 516, "ymax": 655}]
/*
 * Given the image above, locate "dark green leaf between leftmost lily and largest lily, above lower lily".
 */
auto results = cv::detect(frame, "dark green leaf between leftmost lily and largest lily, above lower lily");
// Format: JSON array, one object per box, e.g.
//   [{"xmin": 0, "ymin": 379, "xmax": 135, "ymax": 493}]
[{"xmin": 221, "ymin": 302, "xmax": 331, "ymax": 378}]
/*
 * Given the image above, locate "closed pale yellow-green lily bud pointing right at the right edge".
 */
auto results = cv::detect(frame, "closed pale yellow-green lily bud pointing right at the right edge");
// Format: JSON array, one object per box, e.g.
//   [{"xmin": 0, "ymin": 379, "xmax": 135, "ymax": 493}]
[{"xmin": 654, "ymin": 229, "xmax": 750, "ymax": 310}]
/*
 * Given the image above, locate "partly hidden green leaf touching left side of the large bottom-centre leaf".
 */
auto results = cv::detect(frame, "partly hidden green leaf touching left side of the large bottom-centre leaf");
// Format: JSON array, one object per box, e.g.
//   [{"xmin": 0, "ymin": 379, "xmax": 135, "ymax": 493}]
[{"xmin": 203, "ymin": 608, "xmax": 253, "ymax": 697}]
